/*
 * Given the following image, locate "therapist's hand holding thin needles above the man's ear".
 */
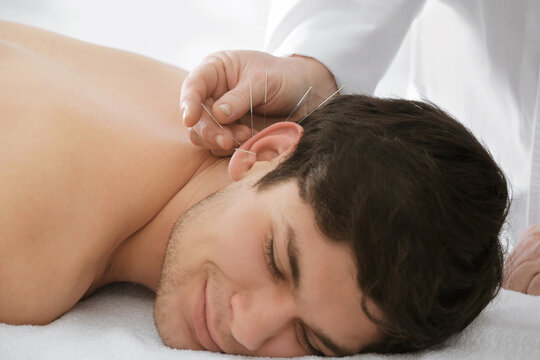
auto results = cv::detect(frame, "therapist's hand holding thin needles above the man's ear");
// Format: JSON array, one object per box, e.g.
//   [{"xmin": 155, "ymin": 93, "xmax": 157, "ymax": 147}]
[{"xmin": 180, "ymin": 51, "xmax": 337, "ymax": 156}]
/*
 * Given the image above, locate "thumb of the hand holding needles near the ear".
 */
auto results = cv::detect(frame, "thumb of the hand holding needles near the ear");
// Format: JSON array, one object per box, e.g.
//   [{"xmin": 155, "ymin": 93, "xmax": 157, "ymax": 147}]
[{"xmin": 212, "ymin": 81, "xmax": 255, "ymax": 124}]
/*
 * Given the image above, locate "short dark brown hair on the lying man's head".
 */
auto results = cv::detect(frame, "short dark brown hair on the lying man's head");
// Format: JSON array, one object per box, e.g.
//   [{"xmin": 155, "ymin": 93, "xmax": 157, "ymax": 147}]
[{"xmin": 255, "ymin": 95, "xmax": 509, "ymax": 352}]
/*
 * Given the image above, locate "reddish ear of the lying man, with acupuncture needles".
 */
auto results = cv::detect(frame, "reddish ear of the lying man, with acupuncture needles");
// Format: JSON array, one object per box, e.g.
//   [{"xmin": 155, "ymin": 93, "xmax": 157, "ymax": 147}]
[{"xmin": 229, "ymin": 121, "xmax": 304, "ymax": 181}]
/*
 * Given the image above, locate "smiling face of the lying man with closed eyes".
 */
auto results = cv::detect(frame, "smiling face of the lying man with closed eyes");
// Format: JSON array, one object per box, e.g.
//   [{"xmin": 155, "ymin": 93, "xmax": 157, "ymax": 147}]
[{"xmin": 154, "ymin": 181, "xmax": 381, "ymax": 357}]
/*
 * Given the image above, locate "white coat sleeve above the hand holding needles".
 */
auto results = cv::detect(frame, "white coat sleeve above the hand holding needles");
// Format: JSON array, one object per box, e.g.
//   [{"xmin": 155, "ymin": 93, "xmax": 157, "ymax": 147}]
[{"xmin": 265, "ymin": 0, "xmax": 425, "ymax": 93}]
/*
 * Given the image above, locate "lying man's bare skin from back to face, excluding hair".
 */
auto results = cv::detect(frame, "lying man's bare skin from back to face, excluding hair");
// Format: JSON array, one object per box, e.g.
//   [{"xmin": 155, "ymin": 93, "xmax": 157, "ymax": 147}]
[{"xmin": 0, "ymin": 22, "xmax": 380, "ymax": 356}]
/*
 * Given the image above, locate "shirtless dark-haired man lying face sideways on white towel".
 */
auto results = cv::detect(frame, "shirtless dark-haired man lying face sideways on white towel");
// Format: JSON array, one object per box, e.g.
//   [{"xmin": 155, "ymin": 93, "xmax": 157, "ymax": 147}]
[{"xmin": 0, "ymin": 22, "xmax": 532, "ymax": 356}]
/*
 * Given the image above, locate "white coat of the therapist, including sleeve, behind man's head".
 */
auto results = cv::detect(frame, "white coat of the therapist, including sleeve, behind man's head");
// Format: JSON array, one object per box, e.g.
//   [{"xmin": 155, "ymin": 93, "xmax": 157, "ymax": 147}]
[{"xmin": 266, "ymin": 0, "xmax": 540, "ymax": 245}]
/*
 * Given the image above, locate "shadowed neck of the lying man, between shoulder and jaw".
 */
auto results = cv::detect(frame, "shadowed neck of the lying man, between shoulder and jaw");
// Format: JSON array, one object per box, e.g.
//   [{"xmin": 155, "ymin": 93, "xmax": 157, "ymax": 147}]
[{"xmin": 99, "ymin": 153, "xmax": 231, "ymax": 291}]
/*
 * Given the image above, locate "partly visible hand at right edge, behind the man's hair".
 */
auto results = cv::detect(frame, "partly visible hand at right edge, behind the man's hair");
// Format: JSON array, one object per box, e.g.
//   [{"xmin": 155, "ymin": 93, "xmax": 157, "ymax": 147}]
[{"xmin": 503, "ymin": 225, "xmax": 540, "ymax": 295}]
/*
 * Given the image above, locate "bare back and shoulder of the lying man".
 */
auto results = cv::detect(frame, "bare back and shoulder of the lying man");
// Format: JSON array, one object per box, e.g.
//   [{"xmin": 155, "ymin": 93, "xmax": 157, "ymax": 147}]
[{"xmin": 0, "ymin": 22, "xmax": 207, "ymax": 323}]
